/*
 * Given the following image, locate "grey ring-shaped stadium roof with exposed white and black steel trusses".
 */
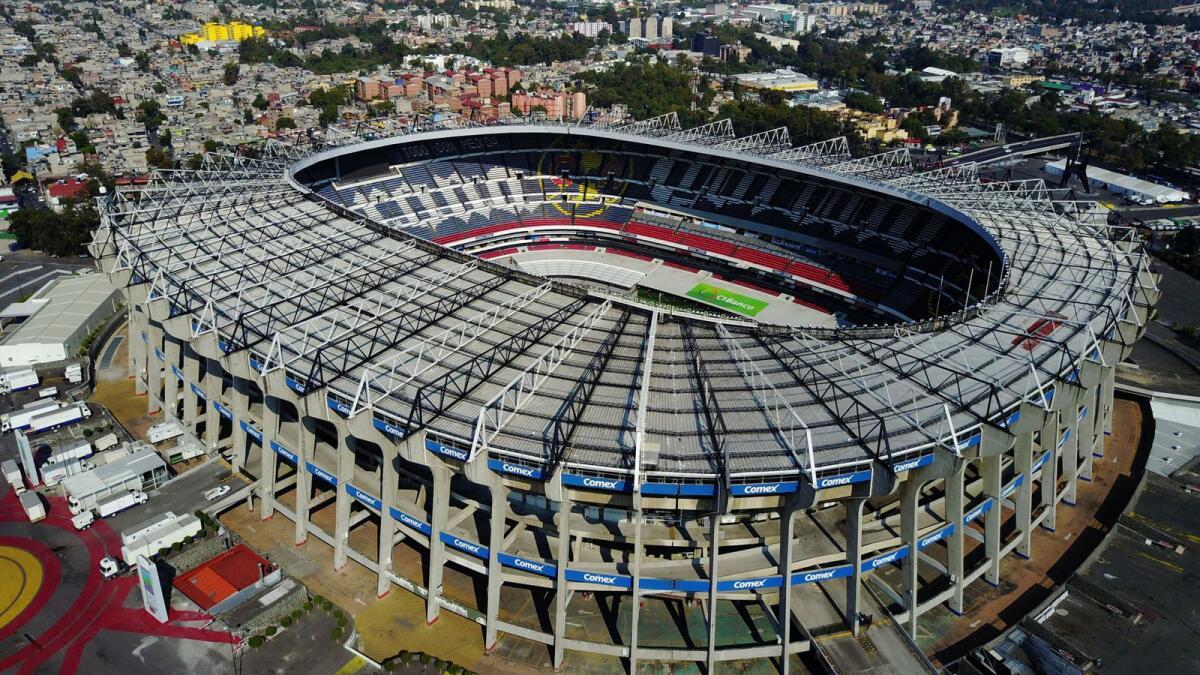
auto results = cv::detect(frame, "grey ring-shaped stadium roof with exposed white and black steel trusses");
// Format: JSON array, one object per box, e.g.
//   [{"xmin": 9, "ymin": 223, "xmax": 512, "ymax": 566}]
[{"xmin": 97, "ymin": 112, "xmax": 1146, "ymax": 482}]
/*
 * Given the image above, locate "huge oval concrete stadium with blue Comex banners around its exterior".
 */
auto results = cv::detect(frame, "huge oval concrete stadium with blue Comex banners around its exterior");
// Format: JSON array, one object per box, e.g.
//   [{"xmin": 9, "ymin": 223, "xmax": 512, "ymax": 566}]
[{"xmin": 91, "ymin": 115, "xmax": 1158, "ymax": 671}]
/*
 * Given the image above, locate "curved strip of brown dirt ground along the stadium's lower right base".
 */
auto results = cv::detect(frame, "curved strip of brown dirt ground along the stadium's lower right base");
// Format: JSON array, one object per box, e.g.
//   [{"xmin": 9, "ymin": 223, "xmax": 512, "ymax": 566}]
[{"xmin": 917, "ymin": 399, "xmax": 1142, "ymax": 664}]
